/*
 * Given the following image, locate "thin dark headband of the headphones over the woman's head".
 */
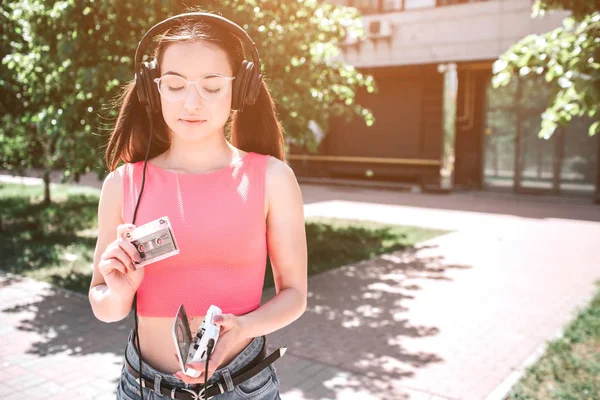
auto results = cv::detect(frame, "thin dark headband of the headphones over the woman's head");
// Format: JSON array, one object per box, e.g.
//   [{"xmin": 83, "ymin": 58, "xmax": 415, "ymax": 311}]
[{"xmin": 134, "ymin": 12, "xmax": 260, "ymax": 77}]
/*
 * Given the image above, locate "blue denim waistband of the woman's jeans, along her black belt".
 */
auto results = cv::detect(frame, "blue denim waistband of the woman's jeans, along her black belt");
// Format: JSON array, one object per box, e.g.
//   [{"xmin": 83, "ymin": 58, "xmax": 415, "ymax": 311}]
[{"xmin": 125, "ymin": 330, "xmax": 265, "ymax": 388}]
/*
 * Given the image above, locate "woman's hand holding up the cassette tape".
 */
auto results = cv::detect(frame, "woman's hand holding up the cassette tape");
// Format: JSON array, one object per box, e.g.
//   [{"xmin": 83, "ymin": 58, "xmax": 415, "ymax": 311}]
[{"xmin": 98, "ymin": 224, "xmax": 144, "ymax": 296}]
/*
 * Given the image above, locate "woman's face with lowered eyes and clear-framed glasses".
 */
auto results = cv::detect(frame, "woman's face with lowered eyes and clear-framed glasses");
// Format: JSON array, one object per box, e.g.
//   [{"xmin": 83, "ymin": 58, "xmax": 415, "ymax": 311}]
[{"xmin": 160, "ymin": 41, "xmax": 233, "ymax": 141}]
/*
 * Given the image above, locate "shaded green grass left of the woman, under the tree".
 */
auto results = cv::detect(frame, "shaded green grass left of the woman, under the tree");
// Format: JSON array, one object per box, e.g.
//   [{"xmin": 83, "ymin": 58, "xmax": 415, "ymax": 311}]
[{"xmin": 0, "ymin": 184, "xmax": 99, "ymax": 293}]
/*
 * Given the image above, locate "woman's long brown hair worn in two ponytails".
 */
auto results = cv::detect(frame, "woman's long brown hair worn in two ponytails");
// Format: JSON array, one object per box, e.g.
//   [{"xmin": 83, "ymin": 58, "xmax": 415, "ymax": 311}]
[{"xmin": 105, "ymin": 12, "xmax": 284, "ymax": 171}]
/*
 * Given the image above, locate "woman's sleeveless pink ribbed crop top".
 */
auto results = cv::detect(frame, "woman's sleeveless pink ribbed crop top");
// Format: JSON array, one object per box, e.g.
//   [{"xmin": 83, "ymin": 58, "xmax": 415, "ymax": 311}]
[{"xmin": 123, "ymin": 153, "xmax": 269, "ymax": 317}]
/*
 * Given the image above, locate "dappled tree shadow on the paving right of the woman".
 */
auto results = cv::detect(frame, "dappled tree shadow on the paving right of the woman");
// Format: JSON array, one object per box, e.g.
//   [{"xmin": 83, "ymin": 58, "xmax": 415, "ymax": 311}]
[{"xmin": 270, "ymin": 242, "xmax": 470, "ymax": 399}]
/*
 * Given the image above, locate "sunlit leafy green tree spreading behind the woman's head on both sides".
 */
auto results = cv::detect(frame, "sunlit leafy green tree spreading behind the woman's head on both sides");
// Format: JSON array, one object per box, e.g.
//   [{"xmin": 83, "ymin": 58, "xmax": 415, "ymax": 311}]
[{"xmin": 0, "ymin": 0, "xmax": 375, "ymax": 202}]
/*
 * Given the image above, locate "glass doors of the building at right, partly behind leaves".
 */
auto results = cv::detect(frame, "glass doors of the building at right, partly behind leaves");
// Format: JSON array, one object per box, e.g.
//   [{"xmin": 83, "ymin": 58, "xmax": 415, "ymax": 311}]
[{"xmin": 483, "ymin": 77, "xmax": 600, "ymax": 194}]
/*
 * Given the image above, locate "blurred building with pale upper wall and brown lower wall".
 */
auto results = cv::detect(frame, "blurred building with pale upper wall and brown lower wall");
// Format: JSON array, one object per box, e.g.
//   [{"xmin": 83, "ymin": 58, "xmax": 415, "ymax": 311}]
[{"xmin": 289, "ymin": 0, "xmax": 600, "ymax": 200}]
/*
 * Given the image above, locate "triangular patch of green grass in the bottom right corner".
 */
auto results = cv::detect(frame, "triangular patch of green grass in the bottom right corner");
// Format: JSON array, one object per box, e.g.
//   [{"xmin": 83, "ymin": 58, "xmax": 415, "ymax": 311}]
[{"xmin": 510, "ymin": 282, "xmax": 600, "ymax": 400}]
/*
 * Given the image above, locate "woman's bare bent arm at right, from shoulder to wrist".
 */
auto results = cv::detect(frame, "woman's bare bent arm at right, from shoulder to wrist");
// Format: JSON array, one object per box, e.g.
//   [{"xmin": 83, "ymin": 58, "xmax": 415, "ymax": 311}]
[{"xmin": 239, "ymin": 157, "xmax": 308, "ymax": 338}]
